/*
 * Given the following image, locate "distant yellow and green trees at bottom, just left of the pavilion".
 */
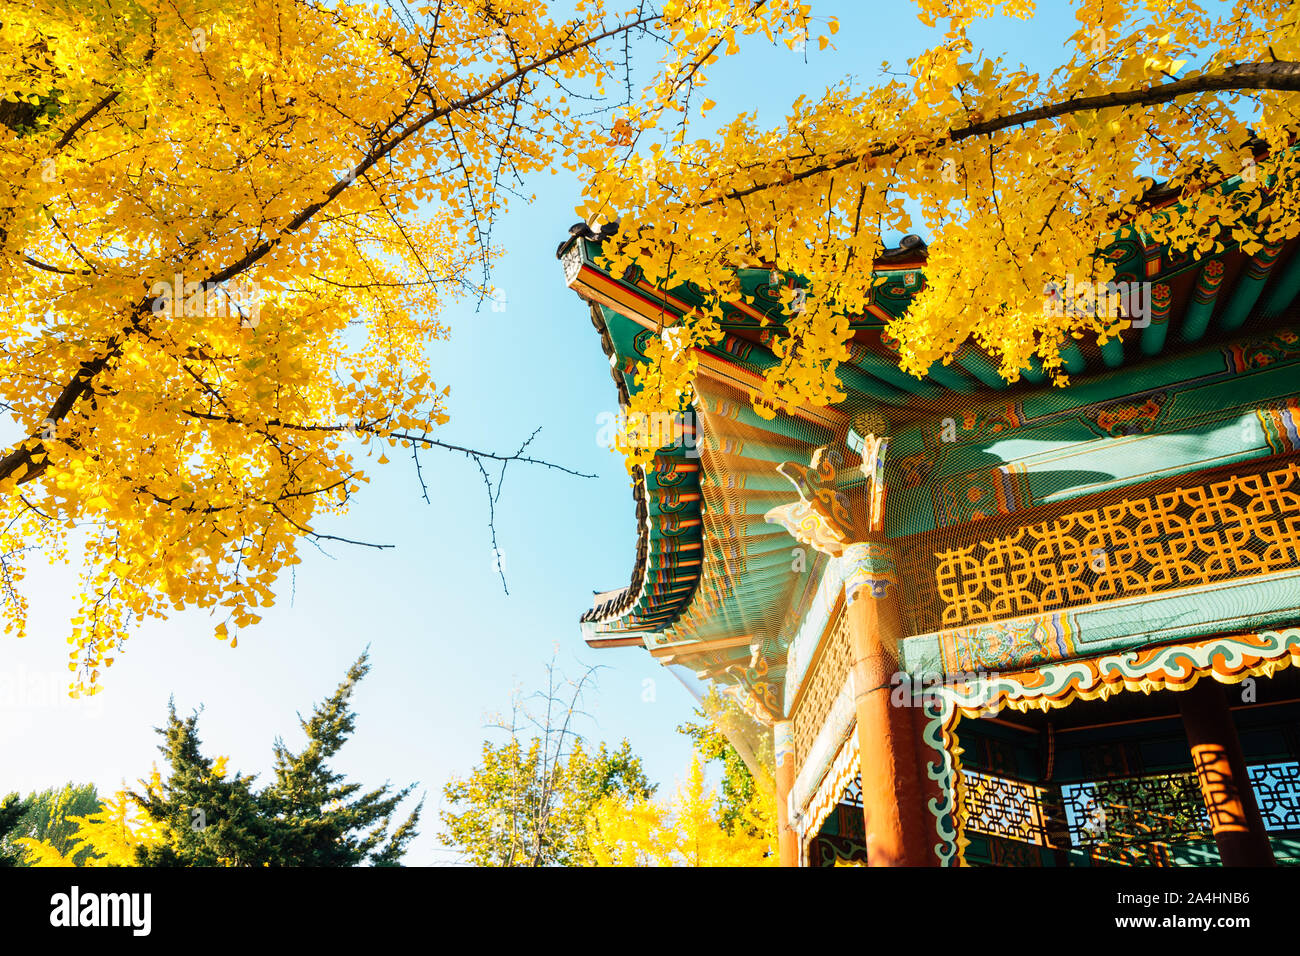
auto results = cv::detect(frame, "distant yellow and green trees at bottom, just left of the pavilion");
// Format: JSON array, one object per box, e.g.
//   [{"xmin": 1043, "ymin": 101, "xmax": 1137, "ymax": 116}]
[{"xmin": 441, "ymin": 661, "xmax": 776, "ymax": 866}]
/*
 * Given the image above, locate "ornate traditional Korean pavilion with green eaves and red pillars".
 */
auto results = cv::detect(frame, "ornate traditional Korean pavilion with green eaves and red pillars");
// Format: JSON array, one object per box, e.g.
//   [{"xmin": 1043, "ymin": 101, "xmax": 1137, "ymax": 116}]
[{"xmin": 558, "ymin": 164, "xmax": 1300, "ymax": 866}]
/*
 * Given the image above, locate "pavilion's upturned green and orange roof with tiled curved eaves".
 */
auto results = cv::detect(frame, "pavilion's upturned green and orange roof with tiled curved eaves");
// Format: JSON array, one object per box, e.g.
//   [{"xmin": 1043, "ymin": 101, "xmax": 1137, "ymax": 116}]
[{"xmin": 558, "ymin": 158, "xmax": 1300, "ymax": 712}]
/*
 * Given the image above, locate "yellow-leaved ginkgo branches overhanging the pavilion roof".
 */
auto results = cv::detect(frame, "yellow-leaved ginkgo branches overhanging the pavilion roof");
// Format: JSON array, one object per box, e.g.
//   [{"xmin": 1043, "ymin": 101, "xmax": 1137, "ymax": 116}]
[{"xmin": 582, "ymin": 0, "xmax": 1300, "ymax": 467}]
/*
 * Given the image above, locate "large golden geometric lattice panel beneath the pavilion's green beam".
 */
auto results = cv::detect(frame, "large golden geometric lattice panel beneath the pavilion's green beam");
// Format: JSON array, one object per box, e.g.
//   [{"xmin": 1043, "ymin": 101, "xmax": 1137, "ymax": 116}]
[{"xmin": 904, "ymin": 462, "xmax": 1300, "ymax": 633}]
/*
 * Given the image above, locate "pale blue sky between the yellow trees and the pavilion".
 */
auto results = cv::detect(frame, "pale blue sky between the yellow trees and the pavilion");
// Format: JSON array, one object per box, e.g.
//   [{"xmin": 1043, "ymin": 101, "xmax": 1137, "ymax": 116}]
[{"xmin": 0, "ymin": 1, "xmax": 1074, "ymax": 864}]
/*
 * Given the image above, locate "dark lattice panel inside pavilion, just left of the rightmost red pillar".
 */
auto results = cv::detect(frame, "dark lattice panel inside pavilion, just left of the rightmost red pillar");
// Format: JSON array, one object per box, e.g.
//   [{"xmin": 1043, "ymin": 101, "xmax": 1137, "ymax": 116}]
[{"xmin": 1061, "ymin": 773, "xmax": 1213, "ymax": 847}]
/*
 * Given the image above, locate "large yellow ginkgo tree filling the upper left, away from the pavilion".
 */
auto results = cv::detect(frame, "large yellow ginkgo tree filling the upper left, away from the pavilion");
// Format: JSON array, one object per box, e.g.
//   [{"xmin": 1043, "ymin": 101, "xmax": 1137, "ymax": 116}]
[{"xmin": 0, "ymin": 0, "xmax": 798, "ymax": 691}]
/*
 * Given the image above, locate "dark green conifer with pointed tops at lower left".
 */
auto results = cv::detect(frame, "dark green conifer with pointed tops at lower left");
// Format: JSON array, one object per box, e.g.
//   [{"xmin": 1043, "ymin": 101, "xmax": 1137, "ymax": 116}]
[{"xmin": 134, "ymin": 654, "xmax": 421, "ymax": 866}]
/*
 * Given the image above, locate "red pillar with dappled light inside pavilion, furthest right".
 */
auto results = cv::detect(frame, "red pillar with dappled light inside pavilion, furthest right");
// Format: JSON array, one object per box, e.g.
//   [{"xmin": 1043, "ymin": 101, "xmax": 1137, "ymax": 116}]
[{"xmin": 1178, "ymin": 676, "xmax": 1275, "ymax": 866}]
